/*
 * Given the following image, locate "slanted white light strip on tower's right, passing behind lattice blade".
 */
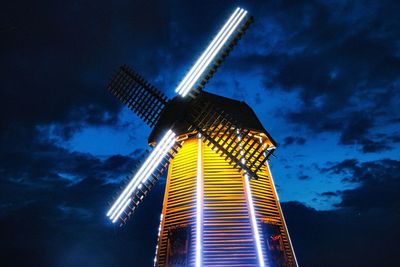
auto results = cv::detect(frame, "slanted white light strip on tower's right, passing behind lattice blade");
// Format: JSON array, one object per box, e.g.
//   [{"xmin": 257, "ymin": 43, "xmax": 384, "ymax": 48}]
[{"xmin": 237, "ymin": 135, "xmax": 265, "ymax": 267}]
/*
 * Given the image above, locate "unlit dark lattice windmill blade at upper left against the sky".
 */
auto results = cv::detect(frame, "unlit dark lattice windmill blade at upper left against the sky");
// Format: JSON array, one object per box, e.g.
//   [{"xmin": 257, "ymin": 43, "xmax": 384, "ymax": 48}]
[{"xmin": 107, "ymin": 65, "xmax": 167, "ymax": 127}]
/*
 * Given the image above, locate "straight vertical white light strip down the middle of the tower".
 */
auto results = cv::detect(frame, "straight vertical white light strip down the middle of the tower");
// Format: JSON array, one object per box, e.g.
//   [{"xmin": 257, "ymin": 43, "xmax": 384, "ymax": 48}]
[{"xmin": 196, "ymin": 134, "xmax": 203, "ymax": 267}]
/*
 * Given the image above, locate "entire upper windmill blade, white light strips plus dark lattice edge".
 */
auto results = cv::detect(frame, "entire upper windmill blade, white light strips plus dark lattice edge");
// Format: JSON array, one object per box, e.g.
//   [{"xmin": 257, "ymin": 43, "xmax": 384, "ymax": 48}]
[{"xmin": 175, "ymin": 8, "xmax": 253, "ymax": 97}]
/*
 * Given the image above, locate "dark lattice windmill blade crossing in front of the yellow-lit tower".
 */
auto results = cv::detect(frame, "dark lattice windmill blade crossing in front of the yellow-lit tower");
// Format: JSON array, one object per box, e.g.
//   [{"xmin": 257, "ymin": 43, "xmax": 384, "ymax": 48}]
[{"xmin": 191, "ymin": 101, "xmax": 275, "ymax": 179}]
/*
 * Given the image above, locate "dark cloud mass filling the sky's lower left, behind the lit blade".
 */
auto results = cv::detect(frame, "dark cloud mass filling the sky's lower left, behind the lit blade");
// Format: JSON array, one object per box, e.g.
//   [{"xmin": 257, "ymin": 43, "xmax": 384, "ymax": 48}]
[{"xmin": 0, "ymin": 139, "xmax": 163, "ymax": 266}]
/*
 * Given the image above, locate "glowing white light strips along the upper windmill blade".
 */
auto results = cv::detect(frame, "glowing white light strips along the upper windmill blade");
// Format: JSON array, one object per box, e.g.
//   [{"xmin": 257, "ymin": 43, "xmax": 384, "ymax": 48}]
[{"xmin": 175, "ymin": 8, "xmax": 247, "ymax": 97}]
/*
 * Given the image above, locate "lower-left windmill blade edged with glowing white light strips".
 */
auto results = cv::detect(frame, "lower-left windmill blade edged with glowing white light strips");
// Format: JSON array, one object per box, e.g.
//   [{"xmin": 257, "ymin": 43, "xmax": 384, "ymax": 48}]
[{"xmin": 107, "ymin": 130, "xmax": 181, "ymax": 226}]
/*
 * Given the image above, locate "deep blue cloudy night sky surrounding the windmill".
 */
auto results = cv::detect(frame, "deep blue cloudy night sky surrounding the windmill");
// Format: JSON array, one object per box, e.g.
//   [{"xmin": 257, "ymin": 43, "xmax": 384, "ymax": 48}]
[{"xmin": 0, "ymin": 0, "xmax": 400, "ymax": 266}]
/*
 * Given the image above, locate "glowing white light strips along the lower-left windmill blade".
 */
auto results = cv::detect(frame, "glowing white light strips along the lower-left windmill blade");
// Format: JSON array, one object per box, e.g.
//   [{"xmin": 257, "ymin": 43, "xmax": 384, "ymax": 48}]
[{"xmin": 107, "ymin": 130, "xmax": 176, "ymax": 223}]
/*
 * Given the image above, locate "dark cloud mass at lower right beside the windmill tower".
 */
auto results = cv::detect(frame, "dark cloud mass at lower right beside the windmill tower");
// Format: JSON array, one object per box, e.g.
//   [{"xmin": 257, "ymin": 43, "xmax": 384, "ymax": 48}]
[{"xmin": 283, "ymin": 160, "xmax": 400, "ymax": 266}]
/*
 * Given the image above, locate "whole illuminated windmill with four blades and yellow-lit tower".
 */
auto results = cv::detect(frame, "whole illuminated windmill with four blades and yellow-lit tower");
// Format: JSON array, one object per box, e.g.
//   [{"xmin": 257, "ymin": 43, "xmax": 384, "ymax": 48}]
[{"xmin": 107, "ymin": 8, "xmax": 297, "ymax": 266}]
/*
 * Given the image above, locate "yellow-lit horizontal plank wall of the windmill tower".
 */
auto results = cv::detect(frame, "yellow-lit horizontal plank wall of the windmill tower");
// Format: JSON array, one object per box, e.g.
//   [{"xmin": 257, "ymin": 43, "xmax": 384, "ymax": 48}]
[{"xmin": 156, "ymin": 137, "xmax": 297, "ymax": 267}]
